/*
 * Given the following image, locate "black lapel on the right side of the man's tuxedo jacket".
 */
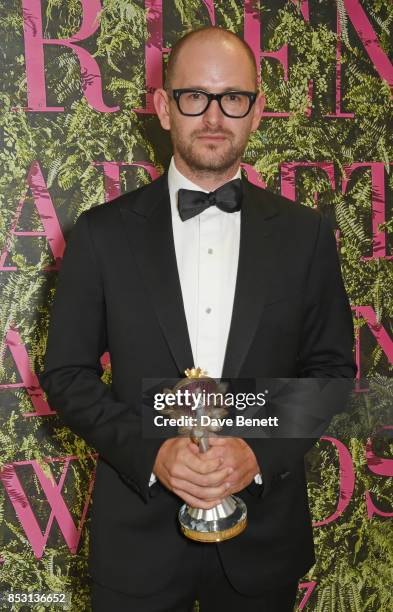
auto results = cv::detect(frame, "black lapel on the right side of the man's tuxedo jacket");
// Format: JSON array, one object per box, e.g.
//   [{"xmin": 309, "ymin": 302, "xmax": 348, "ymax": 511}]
[{"xmin": 222, "ymin": 177, "xmax": 279, "ymax": 378}]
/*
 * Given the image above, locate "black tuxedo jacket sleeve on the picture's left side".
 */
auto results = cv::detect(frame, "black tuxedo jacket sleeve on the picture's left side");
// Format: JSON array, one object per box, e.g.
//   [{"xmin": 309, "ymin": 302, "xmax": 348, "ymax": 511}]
[{"xmin": 38, "ymin": 211, "xmax": 162, "ymax": 502}]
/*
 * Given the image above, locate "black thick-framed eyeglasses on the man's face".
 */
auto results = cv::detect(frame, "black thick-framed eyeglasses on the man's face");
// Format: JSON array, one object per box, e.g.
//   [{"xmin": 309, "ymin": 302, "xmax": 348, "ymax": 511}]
[{"xmin": 168, "ymin": 89, "xmax": 258, "ymax": 119}]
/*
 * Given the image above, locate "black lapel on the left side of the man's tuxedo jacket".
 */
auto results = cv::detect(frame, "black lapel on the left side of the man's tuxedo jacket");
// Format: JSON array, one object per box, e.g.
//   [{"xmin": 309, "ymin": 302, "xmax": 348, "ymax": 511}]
[{"xmin": 120, "ymin": 172, "xmax": 194, "ymax": 376}]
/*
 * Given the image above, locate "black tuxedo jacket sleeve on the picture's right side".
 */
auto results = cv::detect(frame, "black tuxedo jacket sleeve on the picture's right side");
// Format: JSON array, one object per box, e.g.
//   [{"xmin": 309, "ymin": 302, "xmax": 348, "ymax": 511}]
[{"xmin": 247, "ymin": 216, "xmax": 356, "ymax": 497}]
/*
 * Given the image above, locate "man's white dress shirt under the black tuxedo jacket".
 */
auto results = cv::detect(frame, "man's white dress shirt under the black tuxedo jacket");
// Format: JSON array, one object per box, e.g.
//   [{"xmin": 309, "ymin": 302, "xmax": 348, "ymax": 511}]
[{"xmin": 149, "ymin": 157, "xmax": 262, "ymax": 485}]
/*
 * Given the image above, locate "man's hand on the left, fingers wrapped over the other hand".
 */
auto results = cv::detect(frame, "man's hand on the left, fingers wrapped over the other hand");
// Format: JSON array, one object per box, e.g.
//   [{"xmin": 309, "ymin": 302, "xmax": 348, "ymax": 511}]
[{"xmin": 153, "ymin": 438, "xmax": 233, "ymax": 509}]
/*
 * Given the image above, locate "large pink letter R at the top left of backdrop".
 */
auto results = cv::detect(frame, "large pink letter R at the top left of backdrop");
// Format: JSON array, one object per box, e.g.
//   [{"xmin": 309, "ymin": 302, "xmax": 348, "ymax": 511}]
[{"xmin": 22, "ymin": 0, "xmax": 120, "ymax": 113}]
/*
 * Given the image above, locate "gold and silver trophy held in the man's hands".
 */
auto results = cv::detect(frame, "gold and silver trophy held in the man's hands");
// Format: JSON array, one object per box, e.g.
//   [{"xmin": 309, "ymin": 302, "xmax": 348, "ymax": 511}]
[{"xmin": 160, "ymin": 368, "xmax": 247, "ymax": 542}]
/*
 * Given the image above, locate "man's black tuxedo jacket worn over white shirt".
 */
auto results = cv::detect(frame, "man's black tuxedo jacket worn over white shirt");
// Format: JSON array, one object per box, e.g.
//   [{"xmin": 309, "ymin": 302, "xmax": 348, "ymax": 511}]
[{"xmin": 40, "ymin": 173, "xmax": 355, "ymax": 596}]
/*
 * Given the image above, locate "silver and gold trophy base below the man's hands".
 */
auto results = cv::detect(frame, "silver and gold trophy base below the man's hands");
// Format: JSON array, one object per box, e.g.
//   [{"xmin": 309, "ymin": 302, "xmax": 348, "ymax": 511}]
[{"xmin": 179, "ymin": 495, "xmax": 247, "ymax": 543}]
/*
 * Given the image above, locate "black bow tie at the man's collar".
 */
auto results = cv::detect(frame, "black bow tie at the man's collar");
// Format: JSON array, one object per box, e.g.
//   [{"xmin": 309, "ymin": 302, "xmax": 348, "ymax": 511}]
[{"xmin": 178, "ymin": 179, "xmax": 243, "ymax": 221}]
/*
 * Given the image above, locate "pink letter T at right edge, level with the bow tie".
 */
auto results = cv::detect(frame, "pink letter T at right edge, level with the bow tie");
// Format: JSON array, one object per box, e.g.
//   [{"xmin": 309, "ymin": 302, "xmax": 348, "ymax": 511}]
[{"xmin": 342, "ymin": 162, "xmax": 393, "ymax": 261}]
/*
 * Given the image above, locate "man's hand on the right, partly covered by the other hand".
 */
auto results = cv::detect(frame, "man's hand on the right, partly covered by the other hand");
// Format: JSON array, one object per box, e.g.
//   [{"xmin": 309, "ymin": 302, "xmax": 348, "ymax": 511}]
[{"xmin": 202, "ymin": 436, "xmax": 261, "ymax": 495}]
